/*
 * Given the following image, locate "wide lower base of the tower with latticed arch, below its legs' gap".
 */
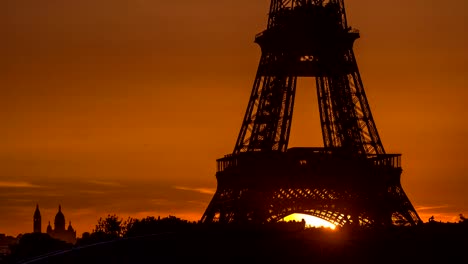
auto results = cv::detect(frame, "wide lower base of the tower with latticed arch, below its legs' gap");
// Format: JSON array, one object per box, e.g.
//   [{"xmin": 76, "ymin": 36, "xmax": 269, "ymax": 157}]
[{"xmin": 202, "ymin": 151, "xmax": 421, "ymax": 226}]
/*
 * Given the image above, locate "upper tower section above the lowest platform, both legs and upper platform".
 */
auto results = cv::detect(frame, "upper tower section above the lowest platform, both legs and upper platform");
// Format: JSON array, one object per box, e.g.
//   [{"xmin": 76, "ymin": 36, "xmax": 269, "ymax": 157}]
[{"xmin": 233, "ymin": 1, "xmax": 385, "ymax": 154}]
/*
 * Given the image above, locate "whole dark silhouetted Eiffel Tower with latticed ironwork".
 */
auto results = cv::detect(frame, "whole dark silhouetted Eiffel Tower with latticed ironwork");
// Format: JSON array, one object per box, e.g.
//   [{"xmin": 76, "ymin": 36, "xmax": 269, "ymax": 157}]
[{"xmin": 201, "ymin": 0, "xmax": 422, "ymax": 227}]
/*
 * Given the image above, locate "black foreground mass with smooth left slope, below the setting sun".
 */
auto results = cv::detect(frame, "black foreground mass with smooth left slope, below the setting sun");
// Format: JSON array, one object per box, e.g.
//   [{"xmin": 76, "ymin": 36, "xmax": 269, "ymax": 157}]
[{"xmin": 13, "ymin": 223, "xmax": 468, "ymax": 264}]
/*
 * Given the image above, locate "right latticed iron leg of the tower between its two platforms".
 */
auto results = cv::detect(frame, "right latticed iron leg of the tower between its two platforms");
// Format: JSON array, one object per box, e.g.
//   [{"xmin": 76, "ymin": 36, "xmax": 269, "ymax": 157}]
[{"xmin": 316, "ymin": 50, "xmax": 385, "ymax": 154}]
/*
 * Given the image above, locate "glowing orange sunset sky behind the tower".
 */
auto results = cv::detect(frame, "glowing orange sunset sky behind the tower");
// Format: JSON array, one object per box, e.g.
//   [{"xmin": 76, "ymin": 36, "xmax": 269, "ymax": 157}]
[{"xmin": 0, "ymin": 0, "xmax": 468, "ymax": 235}]
